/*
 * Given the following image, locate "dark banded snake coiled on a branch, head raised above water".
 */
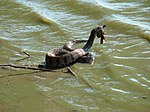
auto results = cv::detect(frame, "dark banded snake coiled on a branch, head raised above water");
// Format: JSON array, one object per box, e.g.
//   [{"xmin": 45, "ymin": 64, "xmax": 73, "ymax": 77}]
[{"xmin": 45, "ymin": 25, "xmax": 106, "ymax": 69}]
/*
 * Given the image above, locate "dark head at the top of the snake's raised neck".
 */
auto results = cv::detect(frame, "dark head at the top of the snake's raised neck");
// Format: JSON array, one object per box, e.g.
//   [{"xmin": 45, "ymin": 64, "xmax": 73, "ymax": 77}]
[{"xmin": 95, "ymin": 25, "xmax": 106, "ymax": 44}]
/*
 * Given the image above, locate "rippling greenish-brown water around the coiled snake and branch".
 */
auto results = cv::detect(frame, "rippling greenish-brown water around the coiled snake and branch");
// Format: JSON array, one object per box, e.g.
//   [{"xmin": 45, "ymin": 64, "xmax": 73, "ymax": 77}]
[{"xmin": 0, "ymin": 0, "xmax": 150, "ymax": 112}]
